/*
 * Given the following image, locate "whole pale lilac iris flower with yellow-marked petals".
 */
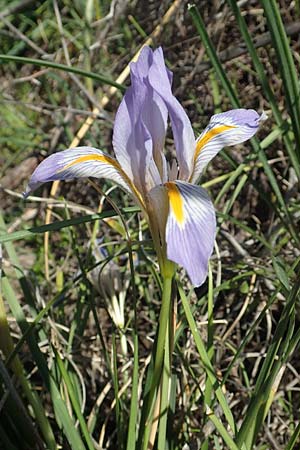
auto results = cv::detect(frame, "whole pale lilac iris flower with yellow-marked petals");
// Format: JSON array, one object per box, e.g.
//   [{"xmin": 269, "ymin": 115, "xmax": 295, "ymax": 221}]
[{"xmin": 25, "ymin": 47, "xmax": 263, "ymax": 286}]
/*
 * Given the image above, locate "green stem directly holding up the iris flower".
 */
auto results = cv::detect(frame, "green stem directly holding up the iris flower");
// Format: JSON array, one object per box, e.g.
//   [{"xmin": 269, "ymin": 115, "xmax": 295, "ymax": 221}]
[{"xmin": 142, "ymin": 268, "xmax": 174, "ymax": 450}]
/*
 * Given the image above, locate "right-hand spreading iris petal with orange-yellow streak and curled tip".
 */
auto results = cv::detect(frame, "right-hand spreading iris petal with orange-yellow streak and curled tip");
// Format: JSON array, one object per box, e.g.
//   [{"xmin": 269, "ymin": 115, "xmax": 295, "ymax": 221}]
[{"xmin": 190, "ymin": 109, "xmax": 266, "ymax": 183}]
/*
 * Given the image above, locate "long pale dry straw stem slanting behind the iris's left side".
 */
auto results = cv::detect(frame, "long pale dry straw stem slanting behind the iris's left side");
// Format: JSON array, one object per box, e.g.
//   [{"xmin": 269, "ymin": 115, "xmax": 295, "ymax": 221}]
[{"xmin": 44, "ymin": 0, "xmax": 181, "ymax": 280}]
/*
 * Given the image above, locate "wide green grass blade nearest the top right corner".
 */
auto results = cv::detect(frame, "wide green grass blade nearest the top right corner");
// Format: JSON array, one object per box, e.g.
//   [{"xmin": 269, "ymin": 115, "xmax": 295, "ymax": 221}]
[{"xmin": 261, "ymin": 0, "xmax": 300, "ymax": 161}]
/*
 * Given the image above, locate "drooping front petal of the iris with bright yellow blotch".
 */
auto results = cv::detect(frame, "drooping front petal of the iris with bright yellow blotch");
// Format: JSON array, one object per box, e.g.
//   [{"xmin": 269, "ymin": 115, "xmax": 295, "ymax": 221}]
[{"xmin": 165, "ymin": 181, "xmax": 216, "ymax": 286}]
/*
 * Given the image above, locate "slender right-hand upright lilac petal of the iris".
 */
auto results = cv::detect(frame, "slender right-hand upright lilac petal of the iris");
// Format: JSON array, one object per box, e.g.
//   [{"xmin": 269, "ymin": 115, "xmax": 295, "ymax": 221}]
[{"xmin": 149, "ymin": 48, "xmax": 195, "ymax": 181}]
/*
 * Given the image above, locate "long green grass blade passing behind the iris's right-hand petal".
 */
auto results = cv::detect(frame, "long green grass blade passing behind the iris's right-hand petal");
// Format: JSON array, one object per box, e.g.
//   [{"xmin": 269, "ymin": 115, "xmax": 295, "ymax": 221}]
[{"xmin": 188, "ymin": 5, "xmax": 299, "ymax": 242}]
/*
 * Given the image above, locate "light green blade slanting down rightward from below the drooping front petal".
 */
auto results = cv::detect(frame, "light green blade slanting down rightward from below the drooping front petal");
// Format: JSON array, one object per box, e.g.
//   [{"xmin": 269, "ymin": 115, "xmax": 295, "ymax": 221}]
[{"xmin": 178, "ymin": 286, "xmax": 236, "ymax": 433}]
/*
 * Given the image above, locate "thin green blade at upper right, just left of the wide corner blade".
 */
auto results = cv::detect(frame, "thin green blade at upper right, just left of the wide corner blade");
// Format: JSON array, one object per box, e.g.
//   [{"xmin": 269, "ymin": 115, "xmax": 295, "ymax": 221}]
[{"xmin": 227, "ymin": 0, "xmax": 300, "ymax": 180}]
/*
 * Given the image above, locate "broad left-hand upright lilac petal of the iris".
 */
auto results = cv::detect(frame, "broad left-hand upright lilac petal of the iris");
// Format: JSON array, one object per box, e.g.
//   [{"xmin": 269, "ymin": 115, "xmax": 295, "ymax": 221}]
[{"xmin": 113, "ymin": 47, "xmax": 168, "ymax": 191}]
